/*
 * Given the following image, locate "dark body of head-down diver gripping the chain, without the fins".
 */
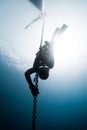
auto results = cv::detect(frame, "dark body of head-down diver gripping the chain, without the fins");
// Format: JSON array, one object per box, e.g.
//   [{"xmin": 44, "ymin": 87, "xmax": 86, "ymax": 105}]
[{"xmin": 25, "ymin": 41, "xmax": 54, "ymax": 96}]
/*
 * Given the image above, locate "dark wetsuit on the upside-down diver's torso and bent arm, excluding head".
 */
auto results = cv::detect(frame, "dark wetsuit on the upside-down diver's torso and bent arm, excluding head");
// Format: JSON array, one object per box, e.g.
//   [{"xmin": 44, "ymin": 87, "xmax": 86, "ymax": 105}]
[{"xmin": 25, "ymin": 44, "xmax": 54, "ymax": 95}]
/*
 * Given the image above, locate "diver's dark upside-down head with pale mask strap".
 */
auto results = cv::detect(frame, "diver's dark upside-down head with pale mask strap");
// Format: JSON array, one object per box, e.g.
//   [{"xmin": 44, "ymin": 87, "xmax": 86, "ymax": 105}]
[{"xmin": 39, "ymin": 66, "xmax": 49, "ymax": 80}]
